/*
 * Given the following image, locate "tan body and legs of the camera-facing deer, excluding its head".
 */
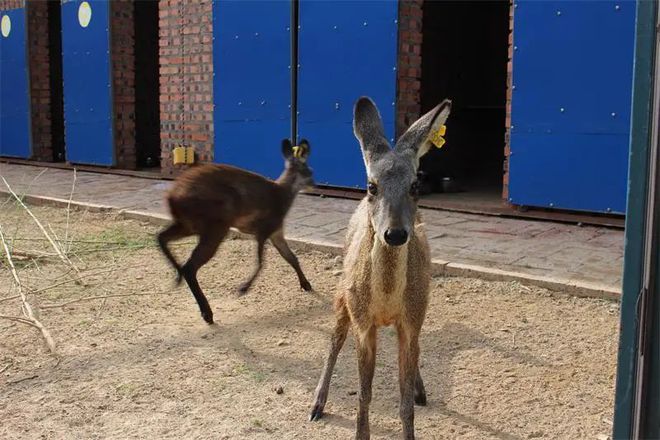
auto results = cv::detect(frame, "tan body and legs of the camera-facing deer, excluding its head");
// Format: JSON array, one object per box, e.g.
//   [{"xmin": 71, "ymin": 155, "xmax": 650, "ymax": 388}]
[{"xmin": 311, "ymin": 198, "xmax": 431, "ymax": 440}]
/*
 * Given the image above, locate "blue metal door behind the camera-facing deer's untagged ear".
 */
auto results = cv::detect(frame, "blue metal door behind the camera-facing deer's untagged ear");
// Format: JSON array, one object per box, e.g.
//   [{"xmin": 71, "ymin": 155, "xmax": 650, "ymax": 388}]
[{"xmin": 298, "ymin": 0, "xmax": 398, "ymax": 187}]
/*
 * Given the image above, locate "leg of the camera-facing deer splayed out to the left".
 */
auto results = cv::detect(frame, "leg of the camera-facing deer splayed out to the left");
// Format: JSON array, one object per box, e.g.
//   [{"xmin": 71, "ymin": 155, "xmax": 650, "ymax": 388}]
[{"xmin": 309, "ymin": 300, "xmax": 351, "ymax": 422}]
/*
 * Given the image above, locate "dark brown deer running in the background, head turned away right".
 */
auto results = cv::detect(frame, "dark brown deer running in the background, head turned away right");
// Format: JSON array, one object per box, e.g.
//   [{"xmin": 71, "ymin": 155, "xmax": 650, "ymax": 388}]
[{"xmin": 158, "ymin": 139, "xmax": 314, "ymax": 324}]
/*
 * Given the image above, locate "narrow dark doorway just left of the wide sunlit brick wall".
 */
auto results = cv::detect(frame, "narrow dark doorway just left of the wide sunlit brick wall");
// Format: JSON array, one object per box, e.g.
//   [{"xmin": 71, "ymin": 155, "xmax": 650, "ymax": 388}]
[{"xmin": 134, "ymin": 0, "xmax": 160, "ymax": 168}]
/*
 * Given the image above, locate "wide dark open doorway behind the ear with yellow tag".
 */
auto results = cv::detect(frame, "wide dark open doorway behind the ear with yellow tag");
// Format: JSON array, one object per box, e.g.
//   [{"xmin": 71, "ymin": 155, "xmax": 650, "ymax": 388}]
[{"xmin": 420, "ymin": 0, "xmax": 509, "ymax": 210}]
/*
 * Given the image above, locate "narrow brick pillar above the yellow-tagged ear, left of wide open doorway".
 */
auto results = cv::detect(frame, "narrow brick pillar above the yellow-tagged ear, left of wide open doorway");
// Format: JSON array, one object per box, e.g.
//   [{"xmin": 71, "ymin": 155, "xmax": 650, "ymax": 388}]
[{"xmin": 396, "ymin": 0, "xmax": 424, "ymax": 137}]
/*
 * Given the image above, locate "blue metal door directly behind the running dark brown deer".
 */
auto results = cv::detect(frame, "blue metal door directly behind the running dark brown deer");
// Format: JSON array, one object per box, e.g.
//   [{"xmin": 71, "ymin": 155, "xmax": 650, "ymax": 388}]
[{"xmin": 213, "ymin": 0, "xmax": 291, "ymax": 177}]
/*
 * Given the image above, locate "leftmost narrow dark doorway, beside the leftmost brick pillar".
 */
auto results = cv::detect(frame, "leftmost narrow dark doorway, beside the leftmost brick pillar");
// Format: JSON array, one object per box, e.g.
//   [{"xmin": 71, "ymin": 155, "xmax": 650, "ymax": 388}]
[{"xmin": 48, "ymin": 0, "xmax": 65, "ymax": 162}]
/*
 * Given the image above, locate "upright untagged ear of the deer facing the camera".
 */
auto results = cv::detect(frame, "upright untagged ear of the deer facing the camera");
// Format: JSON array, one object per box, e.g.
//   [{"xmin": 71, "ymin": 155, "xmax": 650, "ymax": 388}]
[{"xmin": 353, "ymin": 96, "xmax": 390, "ymax": 167}]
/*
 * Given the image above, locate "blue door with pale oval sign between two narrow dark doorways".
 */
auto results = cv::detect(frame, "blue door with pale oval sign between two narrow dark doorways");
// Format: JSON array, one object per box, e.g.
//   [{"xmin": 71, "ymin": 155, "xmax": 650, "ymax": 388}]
[{"xmin": 62, "ymin": 0, "xmax": 115, "ymax": 165}]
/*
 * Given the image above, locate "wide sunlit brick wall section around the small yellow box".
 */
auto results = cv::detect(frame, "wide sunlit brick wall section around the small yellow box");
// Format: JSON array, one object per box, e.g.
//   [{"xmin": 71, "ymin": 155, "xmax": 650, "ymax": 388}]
[{"xmin": 159, "ymin": 0, "xmax": 213, "ymax": 176}]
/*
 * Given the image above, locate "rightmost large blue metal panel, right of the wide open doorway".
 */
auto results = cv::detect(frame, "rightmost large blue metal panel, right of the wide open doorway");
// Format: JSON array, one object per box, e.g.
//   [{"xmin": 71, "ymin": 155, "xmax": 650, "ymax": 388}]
[{"xmin": 509, "ymin": 1, "xmax": 635, "ymax": 213}]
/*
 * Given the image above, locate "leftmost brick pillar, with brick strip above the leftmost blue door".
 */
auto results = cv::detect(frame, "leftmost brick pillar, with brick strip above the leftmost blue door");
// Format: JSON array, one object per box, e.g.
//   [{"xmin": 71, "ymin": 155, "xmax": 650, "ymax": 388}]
[{"xmin": 0, "ymin": 0, "xmax": 53, "ymax": 161}]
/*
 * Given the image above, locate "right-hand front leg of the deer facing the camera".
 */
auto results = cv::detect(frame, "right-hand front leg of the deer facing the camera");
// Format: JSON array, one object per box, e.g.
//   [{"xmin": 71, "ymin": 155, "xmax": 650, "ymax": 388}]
[{"xmin": 397, "ymin": 324, "xmax": 426, "ymax": 440}]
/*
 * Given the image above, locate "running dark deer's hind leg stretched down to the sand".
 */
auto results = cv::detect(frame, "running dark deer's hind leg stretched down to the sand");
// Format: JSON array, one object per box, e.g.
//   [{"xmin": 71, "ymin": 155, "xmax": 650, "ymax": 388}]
[{"xmin": 181, "ymin": 228, "xmax": 228, "ymax": 324}]
